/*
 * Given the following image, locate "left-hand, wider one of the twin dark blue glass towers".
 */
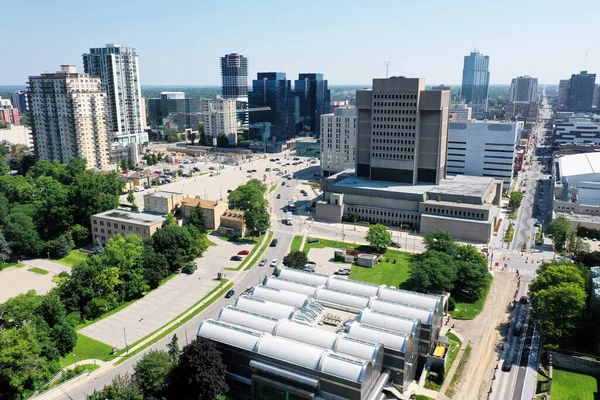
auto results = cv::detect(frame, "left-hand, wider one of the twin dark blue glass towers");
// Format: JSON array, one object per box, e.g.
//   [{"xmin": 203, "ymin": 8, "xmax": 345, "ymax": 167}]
[{"xmin": 248, "ymin": 72, "xmax": 295, "ymax": 141}]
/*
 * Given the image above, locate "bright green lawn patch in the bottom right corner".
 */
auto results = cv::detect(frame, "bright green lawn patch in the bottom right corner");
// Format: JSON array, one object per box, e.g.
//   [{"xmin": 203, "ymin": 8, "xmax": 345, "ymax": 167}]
[{"xmin": 550, "ymin": 368, "xmax": 598, "ymax": 400}]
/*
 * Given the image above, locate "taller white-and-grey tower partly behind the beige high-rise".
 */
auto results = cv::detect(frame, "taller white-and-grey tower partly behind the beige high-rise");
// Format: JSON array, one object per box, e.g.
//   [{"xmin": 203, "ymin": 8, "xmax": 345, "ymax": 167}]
[{"xmin": 83, "ymin": 44, "xmax": 148, "ymax": 162}]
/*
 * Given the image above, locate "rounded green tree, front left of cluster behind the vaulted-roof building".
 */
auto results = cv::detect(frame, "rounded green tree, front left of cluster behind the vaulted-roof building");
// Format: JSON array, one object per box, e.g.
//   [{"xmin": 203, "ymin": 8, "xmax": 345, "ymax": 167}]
[{"xmin": 409, "ymin": 250, "xmax": 457, "ymax": 292}]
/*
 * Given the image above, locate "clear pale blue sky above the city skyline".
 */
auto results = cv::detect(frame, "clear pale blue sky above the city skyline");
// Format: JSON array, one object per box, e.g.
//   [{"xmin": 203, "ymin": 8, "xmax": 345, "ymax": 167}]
[{"xmin": 0, "ymin": 0, "xmax": 600, "ymax": 86}]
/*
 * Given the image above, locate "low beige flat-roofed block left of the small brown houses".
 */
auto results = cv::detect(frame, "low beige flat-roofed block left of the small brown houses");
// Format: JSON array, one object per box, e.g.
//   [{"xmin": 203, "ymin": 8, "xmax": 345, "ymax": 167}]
[{"xmin": 91, "ymin": 209, "xmax": 165, "ymax": 246}]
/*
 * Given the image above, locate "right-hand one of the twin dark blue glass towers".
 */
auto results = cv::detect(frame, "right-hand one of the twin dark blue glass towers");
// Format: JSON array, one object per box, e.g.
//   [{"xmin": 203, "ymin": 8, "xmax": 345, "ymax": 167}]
[{"xmin": 294, "ymin": 73, "xmax": 331, "ymax": 136}]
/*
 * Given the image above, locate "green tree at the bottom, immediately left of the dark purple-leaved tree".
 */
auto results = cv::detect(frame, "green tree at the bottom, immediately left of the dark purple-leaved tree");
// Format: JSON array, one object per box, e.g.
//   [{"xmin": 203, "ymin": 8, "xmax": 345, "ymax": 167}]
[{"xmin": 133, "ymin": 350, "xmax": 175, "ymax": 399}]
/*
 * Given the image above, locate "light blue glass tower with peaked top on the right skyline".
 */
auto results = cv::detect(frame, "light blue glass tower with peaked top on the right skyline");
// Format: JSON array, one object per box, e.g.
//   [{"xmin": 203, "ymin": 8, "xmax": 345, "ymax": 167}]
[{"xmin": 460, "ymin": 50, "xmax": 490, "ymax": 119}]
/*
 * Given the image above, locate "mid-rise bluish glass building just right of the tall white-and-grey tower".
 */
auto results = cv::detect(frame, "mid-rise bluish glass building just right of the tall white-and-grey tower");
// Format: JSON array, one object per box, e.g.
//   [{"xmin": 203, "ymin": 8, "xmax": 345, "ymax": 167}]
[{"xmin": 147, "ymin": 92, "xmax": 203, "ymax": 134}]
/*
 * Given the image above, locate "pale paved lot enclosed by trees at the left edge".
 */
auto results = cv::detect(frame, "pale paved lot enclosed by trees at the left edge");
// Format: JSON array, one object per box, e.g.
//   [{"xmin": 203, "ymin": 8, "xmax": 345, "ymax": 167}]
[{"xmin": 0, "ymin": 259, "xmax": 71, "ymax": 303}]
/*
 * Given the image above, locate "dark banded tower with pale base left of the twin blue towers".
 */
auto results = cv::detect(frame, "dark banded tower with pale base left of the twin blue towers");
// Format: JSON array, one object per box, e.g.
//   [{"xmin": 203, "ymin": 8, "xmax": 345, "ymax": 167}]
[{"xmin": 221, "ymin": 53, "xmax": 248, "ymax": 103}]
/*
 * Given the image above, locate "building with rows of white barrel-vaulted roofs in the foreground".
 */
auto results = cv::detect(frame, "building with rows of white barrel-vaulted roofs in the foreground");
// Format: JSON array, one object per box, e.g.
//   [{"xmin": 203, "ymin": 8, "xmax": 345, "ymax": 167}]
[{"xmin": 198, "ymin": 268, "xmax": 443, "ymax": 400}]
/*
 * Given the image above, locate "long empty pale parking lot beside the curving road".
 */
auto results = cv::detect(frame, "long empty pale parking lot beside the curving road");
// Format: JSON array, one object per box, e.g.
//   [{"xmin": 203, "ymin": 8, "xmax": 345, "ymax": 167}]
[{"xmin": 79, "ymin": 237, "xmax": 252, "ymax": 349}]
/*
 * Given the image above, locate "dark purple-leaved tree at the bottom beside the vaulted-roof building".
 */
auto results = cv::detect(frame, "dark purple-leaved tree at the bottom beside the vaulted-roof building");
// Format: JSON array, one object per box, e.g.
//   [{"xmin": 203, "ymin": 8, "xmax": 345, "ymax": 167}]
[{"xmin": 169, "ymin": 337, "xmax": 229, "ymax": 400}]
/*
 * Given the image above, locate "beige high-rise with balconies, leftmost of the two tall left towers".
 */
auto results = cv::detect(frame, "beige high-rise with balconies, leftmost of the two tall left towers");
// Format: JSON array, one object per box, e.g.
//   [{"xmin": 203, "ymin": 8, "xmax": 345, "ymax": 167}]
[{"xmin": 28, "ymin": 65, "xmax": 109, "ymax": 170}]
